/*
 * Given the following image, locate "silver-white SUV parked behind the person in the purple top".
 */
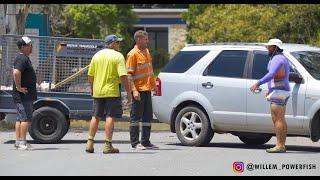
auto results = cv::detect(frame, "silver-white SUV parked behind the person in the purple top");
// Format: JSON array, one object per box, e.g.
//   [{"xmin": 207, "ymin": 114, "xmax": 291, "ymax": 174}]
[{"xmin": 152, "ymin": 43, "xmax": 320, "ymax": 146}]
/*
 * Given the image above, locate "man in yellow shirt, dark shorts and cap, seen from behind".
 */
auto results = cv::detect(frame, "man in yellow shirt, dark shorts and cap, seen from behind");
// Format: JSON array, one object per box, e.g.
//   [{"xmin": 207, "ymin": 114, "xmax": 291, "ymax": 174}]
[{"xmin": 86, "ymin": 35, "xmax": 132, "ymax": 154}]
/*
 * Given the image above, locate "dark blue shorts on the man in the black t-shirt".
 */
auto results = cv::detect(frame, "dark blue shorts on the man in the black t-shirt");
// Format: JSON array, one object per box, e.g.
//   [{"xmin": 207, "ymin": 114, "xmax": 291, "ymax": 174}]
[{"xmin": 15, "ymin": 101, "xmax": 33, "ymax": 122}]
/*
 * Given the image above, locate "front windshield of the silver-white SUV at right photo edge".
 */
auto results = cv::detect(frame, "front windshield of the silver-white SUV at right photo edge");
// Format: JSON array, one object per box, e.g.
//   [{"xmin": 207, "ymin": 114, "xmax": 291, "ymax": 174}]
[{"xmin": 291, "ymin": 51, "xmax": 320, "ymax": 80}]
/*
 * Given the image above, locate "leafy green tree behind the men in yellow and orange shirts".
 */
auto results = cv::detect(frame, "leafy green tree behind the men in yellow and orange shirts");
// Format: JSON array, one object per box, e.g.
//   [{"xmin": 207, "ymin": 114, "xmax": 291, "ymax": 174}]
[{"xmin": 63, "ymin": 4, "xmax": 137, "ymax": 51}]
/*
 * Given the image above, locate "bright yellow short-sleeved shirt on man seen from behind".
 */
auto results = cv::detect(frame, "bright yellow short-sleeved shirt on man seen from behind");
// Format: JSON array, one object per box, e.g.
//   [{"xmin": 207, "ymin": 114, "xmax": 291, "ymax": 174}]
[{"xmin": 88, "ymin": 49, "xmax": 128, "ymax": 98}]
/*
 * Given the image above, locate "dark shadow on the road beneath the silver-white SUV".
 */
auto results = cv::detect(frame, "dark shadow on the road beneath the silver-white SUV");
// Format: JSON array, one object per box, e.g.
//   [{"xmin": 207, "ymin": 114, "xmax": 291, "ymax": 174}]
[{"xmin": 166, "ymin": 143, "xmax": 320, "ymax": 153}]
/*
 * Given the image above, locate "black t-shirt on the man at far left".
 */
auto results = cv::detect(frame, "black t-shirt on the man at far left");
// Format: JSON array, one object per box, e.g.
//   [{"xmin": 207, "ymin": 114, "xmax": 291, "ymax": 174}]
[{"xmin": 12, "ymin": 54, "xmax": 37, "ymax": 102}]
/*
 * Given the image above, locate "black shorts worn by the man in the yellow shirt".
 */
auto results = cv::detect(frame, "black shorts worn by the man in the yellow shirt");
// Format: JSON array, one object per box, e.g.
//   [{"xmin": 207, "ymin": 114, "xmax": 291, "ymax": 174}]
[{"xmin": 93, "ymin": 97, "xmax": 123, "ymax": 119}]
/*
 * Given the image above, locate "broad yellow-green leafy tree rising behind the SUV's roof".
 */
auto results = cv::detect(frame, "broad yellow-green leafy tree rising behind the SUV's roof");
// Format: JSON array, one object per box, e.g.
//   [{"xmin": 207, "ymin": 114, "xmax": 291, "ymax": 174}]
[{"xmin": 183, "ymin": 4, "xmax": 320, "ymax": 44}]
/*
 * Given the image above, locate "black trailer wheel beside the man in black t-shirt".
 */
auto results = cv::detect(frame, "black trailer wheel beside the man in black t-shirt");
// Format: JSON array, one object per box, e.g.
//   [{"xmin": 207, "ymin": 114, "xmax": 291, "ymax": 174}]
[{"xmin": 29, "ymin": 107, "xmax": 69, "ymax": 144}]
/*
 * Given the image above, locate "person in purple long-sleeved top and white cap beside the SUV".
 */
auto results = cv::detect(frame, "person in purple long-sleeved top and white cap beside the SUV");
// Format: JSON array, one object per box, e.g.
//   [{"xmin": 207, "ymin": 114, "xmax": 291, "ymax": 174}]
[{"xmin": 250, "ymin": 39, "xmax": 290, "ymax": 153}]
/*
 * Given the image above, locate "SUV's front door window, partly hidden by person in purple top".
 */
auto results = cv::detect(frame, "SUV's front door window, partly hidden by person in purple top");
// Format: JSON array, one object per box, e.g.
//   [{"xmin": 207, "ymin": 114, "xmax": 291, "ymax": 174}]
[{"xmin": 252, "ymin": 51, "xmax": 295, "ymax": 79}]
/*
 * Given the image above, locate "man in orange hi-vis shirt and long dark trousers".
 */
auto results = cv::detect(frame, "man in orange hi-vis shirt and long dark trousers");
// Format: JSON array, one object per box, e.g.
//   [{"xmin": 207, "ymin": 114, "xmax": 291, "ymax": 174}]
[{"xmin": 126, "ymin": 30, "xmax": 158, "ymax": 150}]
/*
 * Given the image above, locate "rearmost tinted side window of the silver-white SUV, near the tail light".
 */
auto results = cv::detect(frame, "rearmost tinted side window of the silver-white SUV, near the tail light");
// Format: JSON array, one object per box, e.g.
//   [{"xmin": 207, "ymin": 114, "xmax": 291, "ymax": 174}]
[{"xmin": 162, "ymin": 51, "xmax": 209, "ymax": 73}]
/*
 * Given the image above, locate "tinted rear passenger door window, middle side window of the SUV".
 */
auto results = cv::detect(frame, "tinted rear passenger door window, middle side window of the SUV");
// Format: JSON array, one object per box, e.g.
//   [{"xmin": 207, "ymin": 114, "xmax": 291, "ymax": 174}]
[{"xmin": 204, "ymin": 50, "xmax": 248, "ymax": 78}]
